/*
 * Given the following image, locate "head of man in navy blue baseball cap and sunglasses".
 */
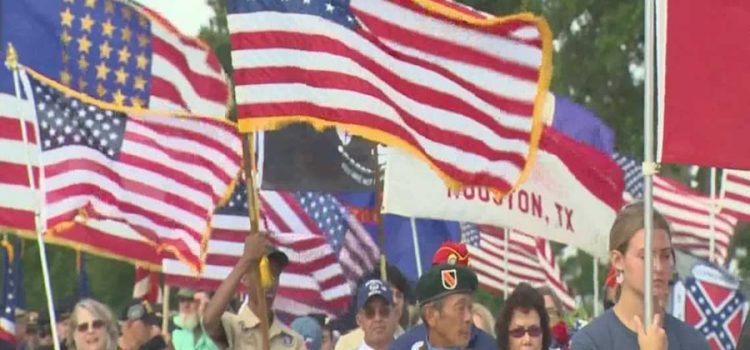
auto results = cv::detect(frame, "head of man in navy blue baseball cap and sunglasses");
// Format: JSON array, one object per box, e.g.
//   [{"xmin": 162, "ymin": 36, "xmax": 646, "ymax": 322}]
[{"xmin": 357, "ymin": 279, "xmax": 397, "ymax": 350}]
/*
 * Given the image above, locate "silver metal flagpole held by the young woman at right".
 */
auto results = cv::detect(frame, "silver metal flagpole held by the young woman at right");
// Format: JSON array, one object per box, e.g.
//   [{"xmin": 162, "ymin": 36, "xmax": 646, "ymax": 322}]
[{"xmin": 643, "ymin": 0, "xmax": 656, "ymax": 328}]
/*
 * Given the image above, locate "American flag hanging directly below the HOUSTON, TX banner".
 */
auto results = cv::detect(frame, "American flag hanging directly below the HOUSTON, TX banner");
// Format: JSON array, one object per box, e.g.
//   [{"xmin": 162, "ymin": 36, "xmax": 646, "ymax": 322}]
[{"xmin": 461, "ymin": 223, "xmax": 576, "ymax": 310}]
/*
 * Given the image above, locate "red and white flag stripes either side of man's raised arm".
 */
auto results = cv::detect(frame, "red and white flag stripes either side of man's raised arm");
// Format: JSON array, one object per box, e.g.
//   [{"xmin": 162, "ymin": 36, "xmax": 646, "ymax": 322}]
[{"xmin": 162, "ymin": 197, "xmax": 351, "ymax": 317}]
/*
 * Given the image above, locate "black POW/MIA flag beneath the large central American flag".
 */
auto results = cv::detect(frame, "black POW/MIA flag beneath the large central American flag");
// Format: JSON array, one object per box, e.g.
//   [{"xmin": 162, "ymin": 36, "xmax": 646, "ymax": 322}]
[{"xmin": 261, "ymin": 124, "xmax": 377, "ymax": 192}]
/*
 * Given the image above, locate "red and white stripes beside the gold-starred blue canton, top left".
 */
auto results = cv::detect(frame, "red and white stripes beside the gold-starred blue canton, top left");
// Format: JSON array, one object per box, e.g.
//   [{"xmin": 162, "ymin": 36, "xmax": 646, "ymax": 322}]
[{"xmin": 130, "ymin": 1, "xmax": 229, "ymax": 117}]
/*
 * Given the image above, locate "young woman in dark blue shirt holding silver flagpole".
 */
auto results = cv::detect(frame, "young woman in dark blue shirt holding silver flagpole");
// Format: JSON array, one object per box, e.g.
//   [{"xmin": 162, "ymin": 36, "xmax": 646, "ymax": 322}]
[{"xmin": 572, "ymin": 202, "xmax": 709, "ymax": 350}]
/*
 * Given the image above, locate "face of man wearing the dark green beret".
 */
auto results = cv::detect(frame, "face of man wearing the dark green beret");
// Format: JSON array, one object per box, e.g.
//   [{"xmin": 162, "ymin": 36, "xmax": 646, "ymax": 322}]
[{"xmin": 426, "ymin": 293, "xmax": 473, "ymax": 348}]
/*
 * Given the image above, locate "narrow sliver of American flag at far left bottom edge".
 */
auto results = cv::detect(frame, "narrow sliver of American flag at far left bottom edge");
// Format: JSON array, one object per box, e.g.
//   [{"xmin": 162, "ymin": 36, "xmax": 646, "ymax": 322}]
[{"xmin": 0, "ymin": 240, "xmax": 22, "ymax": 344}]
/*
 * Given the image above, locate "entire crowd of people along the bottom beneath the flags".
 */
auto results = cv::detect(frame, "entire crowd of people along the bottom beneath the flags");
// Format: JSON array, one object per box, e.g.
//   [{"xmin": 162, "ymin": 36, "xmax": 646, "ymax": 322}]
[{"xmin": 4, "ymin": 203, "xmax": 708, "ymax": 350}]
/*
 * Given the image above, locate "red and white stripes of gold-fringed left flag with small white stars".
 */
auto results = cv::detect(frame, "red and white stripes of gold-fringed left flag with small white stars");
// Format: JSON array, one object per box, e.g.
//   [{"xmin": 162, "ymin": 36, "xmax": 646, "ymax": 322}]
[{"xmin": 22, "ymin": 70, "xmax": 241, "ymax": 268}]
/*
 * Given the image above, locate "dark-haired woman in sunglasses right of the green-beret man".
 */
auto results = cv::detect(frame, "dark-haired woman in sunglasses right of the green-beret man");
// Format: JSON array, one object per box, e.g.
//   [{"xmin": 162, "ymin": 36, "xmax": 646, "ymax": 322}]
[{"xmin": 495, "ymin": 283, "xmax": 552, "ymax": 350}]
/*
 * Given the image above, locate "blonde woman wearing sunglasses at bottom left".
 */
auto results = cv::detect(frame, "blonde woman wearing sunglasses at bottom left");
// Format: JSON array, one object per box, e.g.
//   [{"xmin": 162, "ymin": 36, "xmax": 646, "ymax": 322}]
[{"xmin": 65, "ymin": 299, "xmax": 117, "ymax": 350}]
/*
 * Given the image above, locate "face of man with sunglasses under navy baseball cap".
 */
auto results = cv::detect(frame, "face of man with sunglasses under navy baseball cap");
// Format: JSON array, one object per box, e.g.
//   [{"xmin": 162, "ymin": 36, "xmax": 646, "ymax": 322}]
[{"xmin": 357, "ymin": 297, "xmax": 396, "ymax": 347}]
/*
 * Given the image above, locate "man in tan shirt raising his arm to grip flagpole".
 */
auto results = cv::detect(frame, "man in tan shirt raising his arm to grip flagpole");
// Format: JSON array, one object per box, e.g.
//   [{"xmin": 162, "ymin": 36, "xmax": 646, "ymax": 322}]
[{"xmin": 203, "ymin": 233, "xmax": 305, "ymax": 350}]
